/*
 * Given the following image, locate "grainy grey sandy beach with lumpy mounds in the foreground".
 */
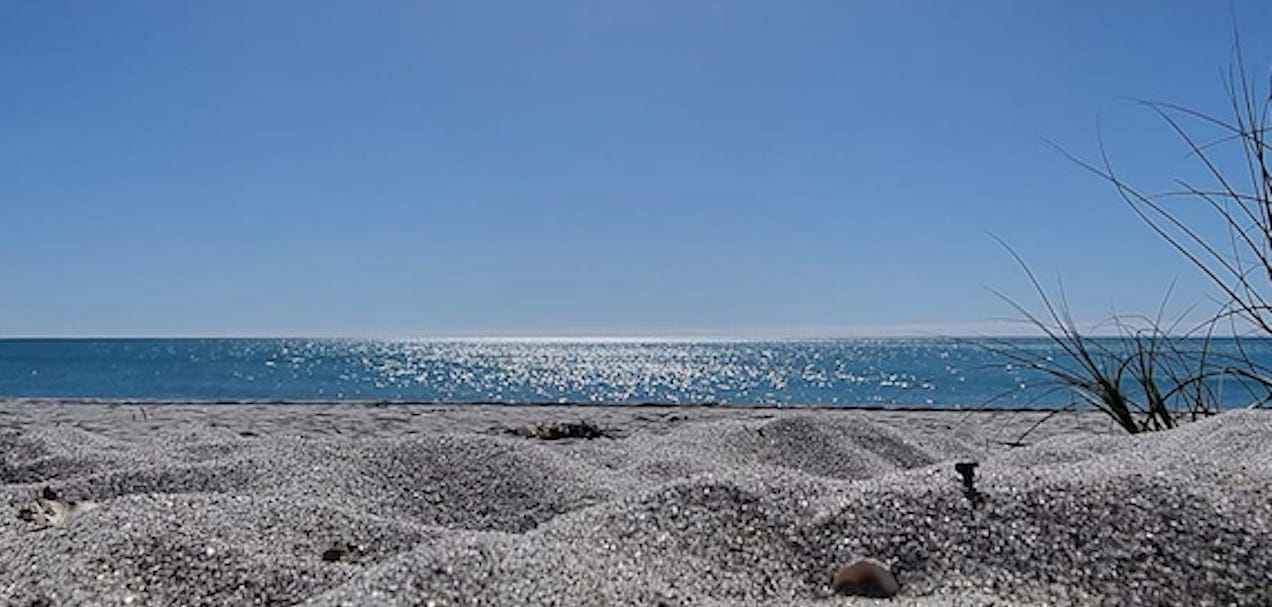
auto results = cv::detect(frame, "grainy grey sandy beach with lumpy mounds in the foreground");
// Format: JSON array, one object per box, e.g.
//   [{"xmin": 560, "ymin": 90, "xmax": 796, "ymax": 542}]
[{"xmin": 0, "ymin": 400, "xmax": 1272, "ymax": 606}]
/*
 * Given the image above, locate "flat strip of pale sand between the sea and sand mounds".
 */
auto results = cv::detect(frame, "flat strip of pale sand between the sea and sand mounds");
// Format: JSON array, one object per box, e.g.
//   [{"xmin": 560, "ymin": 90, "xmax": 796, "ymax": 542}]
[{"xmin": 0, "ymin": 400, "xmax": 1121, "ymax": 443}]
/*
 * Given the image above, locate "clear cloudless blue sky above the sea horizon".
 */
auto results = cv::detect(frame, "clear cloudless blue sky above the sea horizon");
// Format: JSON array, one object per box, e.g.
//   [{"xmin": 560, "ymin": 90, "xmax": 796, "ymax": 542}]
[{"xmin": 0, "ymin": 0, "xmax": 1272, "ymax": 337}]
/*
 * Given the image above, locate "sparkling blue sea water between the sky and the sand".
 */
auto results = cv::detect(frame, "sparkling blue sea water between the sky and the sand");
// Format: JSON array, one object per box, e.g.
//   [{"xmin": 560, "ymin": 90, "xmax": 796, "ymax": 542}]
[{"xmin": 0, "ymin": 338, "xmax": 1272, "ymax": 407}]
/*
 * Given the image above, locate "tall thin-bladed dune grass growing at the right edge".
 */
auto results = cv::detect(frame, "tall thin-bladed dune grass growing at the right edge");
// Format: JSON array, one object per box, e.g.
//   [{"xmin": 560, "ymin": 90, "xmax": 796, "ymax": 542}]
[{"xmin": 990, "ymin": 38, "xmax": 1272, "ymax": 433}]
